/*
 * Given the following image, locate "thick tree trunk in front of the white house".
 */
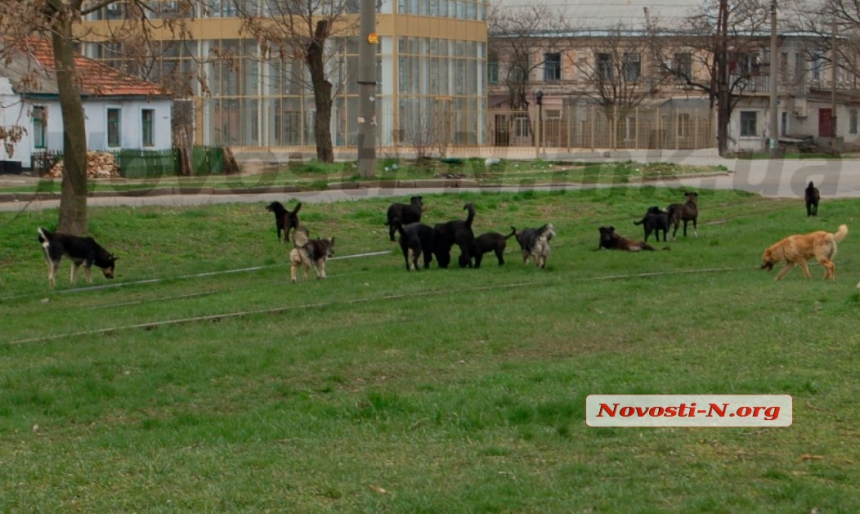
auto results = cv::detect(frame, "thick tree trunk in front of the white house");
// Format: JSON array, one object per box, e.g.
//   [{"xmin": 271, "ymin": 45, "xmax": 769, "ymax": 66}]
[{"xmin": 51, "ymin": 12, "xmax": 88, "ymax": 234}]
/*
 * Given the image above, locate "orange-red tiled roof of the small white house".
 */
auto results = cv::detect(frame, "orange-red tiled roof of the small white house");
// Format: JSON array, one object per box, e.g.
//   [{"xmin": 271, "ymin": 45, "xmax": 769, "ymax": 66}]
[{"xmin": 9, "ymin": 38, "xmax": 169, "ymax": 96}]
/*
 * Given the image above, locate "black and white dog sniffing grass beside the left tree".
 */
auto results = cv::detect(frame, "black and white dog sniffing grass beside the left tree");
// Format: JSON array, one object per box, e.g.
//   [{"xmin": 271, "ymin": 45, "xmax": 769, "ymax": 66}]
[{"xmin": 39, "ymin": 227, "xmax": 119, "ymax": 288}]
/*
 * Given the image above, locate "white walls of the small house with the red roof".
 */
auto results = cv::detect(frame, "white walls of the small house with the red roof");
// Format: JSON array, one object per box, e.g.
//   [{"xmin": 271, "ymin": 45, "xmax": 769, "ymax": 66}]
[{"xmin": 0, "ymin": 90, "xmax": 173, "ymax": 168}]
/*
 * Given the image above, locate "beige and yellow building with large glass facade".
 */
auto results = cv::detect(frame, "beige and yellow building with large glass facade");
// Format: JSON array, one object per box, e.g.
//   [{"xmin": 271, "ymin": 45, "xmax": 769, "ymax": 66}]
[{"xmin": 83, "ymin": 0, "xmax": 487, "ymax": 150}]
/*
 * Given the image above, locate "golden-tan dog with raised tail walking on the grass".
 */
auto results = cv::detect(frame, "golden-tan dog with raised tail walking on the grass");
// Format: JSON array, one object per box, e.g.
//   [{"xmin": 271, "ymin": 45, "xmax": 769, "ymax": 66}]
[{"xmin": 761, "ymin": 225, "xmax": 848, "ymax": 280}]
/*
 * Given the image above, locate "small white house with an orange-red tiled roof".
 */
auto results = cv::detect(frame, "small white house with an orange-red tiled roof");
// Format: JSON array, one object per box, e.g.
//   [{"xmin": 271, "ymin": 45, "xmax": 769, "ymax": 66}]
[{"xmin": 0, "ymin": 40, "xmax": 173, "ymax": 168}]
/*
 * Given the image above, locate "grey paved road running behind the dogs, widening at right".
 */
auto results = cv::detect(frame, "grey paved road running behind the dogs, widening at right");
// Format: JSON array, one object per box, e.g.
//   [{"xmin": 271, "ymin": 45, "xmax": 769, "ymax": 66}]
[{"xmin": 0, "ymin": 150, "xmax": 860, "ymax": 211}]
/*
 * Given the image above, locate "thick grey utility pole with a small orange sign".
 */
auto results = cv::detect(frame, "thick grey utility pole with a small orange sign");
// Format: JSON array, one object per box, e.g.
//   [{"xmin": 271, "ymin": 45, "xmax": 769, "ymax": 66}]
[{"xmin": 358, "ymin": 0, "xmax": 379, "ymax": 178}]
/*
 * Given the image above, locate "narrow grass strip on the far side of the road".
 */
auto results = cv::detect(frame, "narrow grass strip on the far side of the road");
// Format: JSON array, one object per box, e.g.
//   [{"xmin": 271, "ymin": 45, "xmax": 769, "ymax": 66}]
[{"xmin": 0, "ymin": 158, "xmax": 726, "ymax": 193}]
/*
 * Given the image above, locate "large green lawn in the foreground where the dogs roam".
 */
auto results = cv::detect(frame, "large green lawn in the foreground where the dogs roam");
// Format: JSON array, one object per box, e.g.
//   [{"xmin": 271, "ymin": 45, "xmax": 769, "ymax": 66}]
[{"xmin": 0, "ymin": 188, "xmax": 860, "ymax": 513}]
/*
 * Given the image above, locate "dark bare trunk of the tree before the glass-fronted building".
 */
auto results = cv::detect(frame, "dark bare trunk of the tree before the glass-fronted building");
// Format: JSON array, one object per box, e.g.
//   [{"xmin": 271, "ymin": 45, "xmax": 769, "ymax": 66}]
[{"xmin": 306, "ymin": 20, "xmax": 334, "ymax": 162}]
